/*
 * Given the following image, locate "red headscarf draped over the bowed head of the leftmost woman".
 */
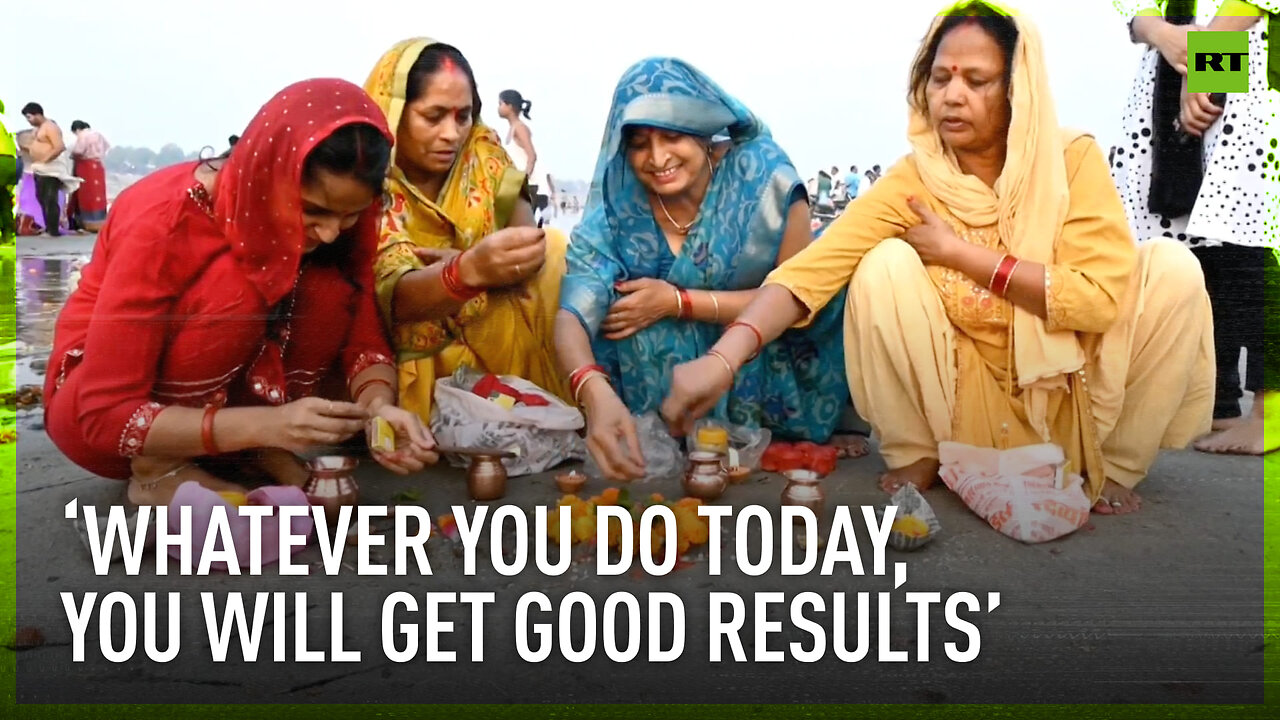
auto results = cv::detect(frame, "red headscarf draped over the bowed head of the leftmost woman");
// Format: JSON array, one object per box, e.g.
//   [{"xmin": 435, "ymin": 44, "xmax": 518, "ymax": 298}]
[{"xmin": 214, "ymin": 79, "xmax": 394, "ymax": 305}]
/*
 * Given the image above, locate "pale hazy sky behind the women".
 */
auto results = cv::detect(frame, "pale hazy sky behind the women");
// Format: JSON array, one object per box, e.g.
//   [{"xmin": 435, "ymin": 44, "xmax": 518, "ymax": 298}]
[{"xmin": 0, "ymin": 0, "xmax": 1140, "ymax": 179}]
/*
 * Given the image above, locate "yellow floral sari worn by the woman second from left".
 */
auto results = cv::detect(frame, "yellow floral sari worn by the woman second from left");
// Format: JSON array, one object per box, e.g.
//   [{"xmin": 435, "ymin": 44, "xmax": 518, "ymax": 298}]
[{"xmin": 365, "ymin": 37, "xmax": 571, "ymax": 420}]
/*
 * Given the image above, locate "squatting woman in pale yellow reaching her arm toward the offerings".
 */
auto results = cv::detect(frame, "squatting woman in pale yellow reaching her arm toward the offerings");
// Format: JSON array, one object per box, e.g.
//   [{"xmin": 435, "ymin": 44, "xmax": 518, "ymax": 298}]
[{"xmin": 663, "ymin": 1, "xmax": 1213, "ymax": 514}]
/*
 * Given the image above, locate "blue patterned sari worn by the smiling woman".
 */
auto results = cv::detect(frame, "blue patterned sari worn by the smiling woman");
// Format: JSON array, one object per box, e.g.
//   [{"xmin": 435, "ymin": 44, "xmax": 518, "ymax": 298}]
[{"xmin": 561, "ymin": 58, "xmax": 849, "ymax": 442}]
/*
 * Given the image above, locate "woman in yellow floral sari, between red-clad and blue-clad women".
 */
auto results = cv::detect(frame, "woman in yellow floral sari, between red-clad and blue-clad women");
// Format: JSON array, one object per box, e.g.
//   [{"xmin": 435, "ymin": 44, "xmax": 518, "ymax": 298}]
[{"xmin": 365, "ymin": 38, "xmax": 570, "ymax": 419}]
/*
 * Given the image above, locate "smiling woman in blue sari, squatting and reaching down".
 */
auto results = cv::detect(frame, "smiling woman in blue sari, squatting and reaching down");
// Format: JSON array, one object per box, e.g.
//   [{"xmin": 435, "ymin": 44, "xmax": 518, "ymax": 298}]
[{"xmin": 556, "ymin": 58, "xmax": 849, "ymax": 479}]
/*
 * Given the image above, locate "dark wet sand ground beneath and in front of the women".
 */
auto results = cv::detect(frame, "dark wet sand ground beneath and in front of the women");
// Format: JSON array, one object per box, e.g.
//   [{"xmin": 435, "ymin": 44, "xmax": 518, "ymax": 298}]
[{"xmin": 3, "ymin": 238, "xmax": 1263, "ymax": 703}]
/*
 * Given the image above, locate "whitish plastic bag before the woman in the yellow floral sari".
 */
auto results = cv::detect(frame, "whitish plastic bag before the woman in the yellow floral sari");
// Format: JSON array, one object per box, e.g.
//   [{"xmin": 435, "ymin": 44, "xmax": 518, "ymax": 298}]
[{"xmin": 431, "ymin": 368, "xmax": 586, "ymax": 478}]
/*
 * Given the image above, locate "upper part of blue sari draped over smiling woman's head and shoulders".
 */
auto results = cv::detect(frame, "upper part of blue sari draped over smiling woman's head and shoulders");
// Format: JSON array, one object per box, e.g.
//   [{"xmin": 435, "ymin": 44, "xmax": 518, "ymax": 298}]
[{"xmin": 561, "ymin": 58, "xmax": 801, "ymax": 334}]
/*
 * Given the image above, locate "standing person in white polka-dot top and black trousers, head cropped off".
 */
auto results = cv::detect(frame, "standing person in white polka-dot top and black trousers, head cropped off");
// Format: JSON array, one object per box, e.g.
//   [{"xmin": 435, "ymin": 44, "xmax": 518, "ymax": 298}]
[{"xmin": 1111, "ymin": 0, "xmax": 1280, "ymax": 455}]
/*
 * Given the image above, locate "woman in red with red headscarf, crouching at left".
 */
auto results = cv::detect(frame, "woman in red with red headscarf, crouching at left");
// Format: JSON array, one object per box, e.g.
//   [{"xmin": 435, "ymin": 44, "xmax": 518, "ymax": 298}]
[{"xmin": 45, "ymin": 79, "xmax": 436, "ymax": 505}]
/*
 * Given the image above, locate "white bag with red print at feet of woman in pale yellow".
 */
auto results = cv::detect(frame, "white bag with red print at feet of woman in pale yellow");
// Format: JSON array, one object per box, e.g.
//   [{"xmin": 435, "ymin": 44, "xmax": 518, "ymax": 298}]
[{"xmin": 938, "ymin": 442, "xmax": 1089, "ymax": 543}]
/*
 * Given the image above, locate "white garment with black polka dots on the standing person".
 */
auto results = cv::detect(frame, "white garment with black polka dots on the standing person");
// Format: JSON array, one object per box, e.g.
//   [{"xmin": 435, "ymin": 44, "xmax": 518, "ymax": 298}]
[{"xmin": 1111, "ymin": 9, "xmax": 1277, "ymax": 247}]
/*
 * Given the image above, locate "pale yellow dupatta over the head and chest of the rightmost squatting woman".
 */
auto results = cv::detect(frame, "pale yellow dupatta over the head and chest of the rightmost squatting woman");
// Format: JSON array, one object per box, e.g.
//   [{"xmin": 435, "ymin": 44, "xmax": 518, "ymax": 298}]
[{"xmin": 908, "ymin": 5, "xmax": 1084, "ymax": 442}]
